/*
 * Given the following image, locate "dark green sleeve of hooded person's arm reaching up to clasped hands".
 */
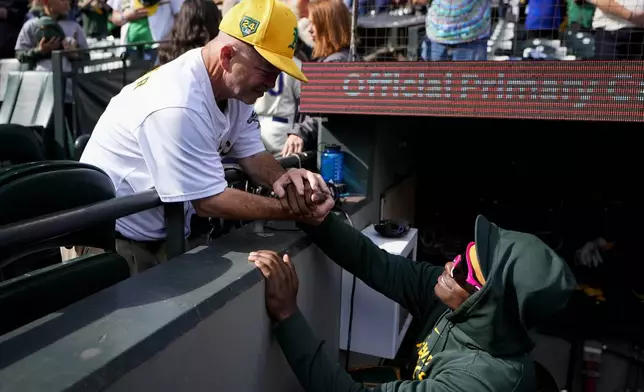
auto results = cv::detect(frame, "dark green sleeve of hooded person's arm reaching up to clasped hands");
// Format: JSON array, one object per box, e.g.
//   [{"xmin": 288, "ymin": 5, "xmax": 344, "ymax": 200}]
[{"xmin": 300, "ymin": 213, "xmax": 443, "ymax": 318}]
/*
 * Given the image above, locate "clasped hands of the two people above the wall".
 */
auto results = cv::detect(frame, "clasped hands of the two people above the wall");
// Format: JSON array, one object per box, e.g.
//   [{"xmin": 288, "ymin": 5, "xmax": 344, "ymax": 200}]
[{"xmin": 273, "ymin": 169, "xmax": 335, "ymax": 225}]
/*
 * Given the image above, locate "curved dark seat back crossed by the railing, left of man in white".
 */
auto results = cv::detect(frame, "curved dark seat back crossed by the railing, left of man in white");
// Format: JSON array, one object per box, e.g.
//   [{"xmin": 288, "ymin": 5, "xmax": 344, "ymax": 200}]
[{"xmin": 0, "ymin": 161, "xmax": 115, "ymax": 279}]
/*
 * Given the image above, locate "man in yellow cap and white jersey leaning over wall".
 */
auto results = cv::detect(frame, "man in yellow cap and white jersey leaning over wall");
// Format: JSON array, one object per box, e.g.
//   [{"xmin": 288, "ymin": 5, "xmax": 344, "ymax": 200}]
[{"xmin": 81, "ymin": 0, "xmax": 333, "ymax": 273}]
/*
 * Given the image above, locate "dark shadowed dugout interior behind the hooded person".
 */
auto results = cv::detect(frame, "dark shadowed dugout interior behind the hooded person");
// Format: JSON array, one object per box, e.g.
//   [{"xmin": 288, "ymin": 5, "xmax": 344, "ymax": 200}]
[{"xmin": 406, "ymin": 117, "xmax": 644, "ymax": 356}]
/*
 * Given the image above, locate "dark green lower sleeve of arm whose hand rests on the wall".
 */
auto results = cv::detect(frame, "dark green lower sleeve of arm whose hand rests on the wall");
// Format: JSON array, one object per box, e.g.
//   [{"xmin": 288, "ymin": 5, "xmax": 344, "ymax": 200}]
[{"xmin": 275, "ymin": 312, "xmax": 492, "ymax": 392}]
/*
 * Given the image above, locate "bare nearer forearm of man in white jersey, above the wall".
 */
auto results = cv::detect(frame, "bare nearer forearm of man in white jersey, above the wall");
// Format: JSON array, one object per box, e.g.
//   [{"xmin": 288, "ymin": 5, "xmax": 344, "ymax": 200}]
[{"xmin": 192, "ymin": 188, "xmax": 297, "ymax": 221}]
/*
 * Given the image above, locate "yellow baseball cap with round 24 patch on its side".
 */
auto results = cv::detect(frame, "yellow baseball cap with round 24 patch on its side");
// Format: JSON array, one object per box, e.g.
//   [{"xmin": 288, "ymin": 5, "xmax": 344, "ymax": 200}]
[{"xmin": 219, "ymin": 0, "xmax": 309, "ymax": 82}]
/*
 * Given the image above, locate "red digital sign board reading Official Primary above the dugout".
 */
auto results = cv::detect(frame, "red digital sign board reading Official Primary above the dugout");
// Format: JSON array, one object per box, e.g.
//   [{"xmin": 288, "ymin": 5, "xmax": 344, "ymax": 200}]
[{"xmin": 300, "ymin": 61, "xmax": 644, "ymax": 121}]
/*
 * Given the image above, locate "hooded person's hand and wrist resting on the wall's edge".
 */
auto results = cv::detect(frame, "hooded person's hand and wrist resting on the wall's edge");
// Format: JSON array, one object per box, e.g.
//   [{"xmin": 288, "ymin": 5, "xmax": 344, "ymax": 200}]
[{"xmin": 248, "ymin": 250, "xmax": 299, "ymax": 322}]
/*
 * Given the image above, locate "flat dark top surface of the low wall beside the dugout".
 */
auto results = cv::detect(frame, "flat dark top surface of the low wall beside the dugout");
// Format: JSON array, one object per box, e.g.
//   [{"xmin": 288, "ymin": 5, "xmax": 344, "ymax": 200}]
[{"xmin": 0, "ymin": 226, "xmax": 310, "ymax": 392}]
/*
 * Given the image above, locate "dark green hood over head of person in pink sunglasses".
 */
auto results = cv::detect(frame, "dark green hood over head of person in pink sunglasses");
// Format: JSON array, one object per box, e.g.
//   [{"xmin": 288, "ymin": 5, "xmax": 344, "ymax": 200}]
[{"xmin": 448, "ymin": 215, "xmax": 576, "ymax": 356}]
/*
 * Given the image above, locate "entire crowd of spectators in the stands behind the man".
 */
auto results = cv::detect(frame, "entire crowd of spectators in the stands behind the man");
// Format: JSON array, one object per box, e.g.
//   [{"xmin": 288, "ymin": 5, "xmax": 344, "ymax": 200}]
[{"xmin": 0, "ymin": 0, "xmax": 644, "ymax": 155}]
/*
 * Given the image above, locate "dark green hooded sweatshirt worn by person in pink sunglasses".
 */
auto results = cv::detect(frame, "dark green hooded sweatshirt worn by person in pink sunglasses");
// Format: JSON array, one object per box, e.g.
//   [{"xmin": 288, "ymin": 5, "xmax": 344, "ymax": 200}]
[{"xmin": 276, "ymin": 214, "xmax": 575, "ymax": 392}]
